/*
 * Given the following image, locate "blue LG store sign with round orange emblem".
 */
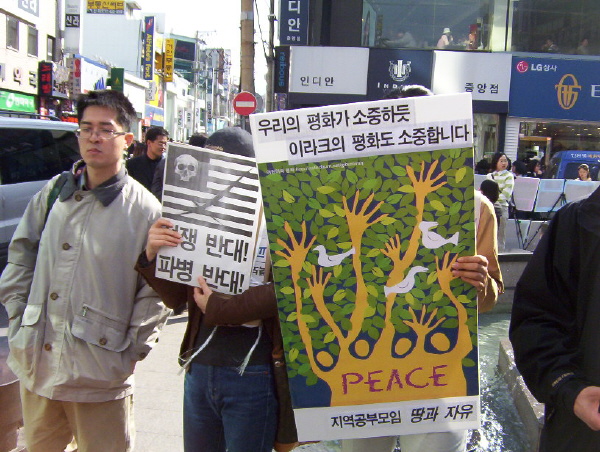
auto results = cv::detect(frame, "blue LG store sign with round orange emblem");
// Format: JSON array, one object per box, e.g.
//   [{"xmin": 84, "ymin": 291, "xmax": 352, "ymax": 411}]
[{"xmin": 509, "ymin": 56, "xmax": 600, "ymax": 121}]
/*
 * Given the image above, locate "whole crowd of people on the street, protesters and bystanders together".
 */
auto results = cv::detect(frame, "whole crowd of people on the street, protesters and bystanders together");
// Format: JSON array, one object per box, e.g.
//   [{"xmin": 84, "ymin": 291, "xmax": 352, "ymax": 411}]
[{"xmin": 0, "ymin": 86, "xmax": 600, "ymax": 452}]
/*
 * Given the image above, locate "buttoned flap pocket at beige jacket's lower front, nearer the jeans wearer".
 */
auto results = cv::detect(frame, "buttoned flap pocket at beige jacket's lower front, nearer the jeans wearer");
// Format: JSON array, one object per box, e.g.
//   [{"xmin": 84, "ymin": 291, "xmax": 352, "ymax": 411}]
[{"xmin": 71, "ymin": 304, "xmax": 129, "ymax": 352}]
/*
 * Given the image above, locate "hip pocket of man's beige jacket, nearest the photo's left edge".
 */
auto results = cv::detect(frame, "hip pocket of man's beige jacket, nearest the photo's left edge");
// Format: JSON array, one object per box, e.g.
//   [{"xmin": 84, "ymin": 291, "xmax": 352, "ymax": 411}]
[{"xmin": 8, "ymin": 304, "xmax": 44, "ymax": 375}]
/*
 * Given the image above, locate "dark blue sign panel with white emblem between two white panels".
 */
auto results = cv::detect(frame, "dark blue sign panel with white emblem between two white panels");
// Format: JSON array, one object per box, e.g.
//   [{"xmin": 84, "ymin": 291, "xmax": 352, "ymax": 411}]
[{"xmin": 367, "ymin": 49, "xmax": 433, "ymax": 100}]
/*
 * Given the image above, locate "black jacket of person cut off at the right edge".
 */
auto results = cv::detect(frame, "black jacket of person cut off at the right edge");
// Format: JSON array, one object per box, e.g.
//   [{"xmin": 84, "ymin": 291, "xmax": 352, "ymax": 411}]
[{"xmin": 509, "ymin": 185, "xmax": 600, "ymax": 452}]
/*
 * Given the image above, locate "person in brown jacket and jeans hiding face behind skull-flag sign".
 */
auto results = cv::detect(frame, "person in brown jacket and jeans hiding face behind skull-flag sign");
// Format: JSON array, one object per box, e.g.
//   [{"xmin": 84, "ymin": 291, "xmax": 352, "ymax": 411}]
[{"xmin": 137, "ymin": 127, "xmax": 297, "ymax": 452}]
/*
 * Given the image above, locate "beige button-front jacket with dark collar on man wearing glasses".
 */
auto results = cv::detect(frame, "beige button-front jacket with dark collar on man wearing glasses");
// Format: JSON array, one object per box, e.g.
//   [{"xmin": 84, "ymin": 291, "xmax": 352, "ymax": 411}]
[{"xmin": 0, "ymin": 170, "xmax": 169, "ymax": 402}]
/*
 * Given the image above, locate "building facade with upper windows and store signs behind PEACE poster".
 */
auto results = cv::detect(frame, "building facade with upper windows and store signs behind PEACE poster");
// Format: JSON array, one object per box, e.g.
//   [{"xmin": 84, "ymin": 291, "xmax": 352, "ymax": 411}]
[{"xmin": 274, "ymin": 0, "xmax": 600, "ymax": 166}]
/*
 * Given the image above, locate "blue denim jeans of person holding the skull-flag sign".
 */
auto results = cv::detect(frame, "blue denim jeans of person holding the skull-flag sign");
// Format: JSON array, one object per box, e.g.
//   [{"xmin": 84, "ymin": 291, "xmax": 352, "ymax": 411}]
[{"xmin": 183, "ymin": 363, "xmax": 277, "ymax": 452}]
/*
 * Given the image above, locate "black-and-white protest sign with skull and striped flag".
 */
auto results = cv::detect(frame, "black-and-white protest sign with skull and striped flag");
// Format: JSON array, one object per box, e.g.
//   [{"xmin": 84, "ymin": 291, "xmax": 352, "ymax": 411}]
[{"xmin": 156, "ymin": 143, "xmax": 265, "ymax": 294}]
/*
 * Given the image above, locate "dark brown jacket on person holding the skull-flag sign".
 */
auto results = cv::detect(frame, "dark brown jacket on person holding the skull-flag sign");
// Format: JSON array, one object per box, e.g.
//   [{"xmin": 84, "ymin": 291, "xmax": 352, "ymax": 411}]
[{"xmin": 136, "ymin": 253, "xmax": 298, "ymax": 452}]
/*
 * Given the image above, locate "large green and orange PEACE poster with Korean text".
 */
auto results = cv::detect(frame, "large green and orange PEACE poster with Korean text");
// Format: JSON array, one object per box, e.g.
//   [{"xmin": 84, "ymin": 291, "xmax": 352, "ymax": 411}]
[{"xmin": 250, "ymin": 94, "xmax": 480, "ymax": 441}]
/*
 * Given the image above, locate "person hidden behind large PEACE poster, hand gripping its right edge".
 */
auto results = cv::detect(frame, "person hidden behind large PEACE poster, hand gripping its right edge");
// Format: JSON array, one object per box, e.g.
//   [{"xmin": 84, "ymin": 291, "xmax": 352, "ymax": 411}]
[{"xmin": 342, "ymin": 85, "xmax": 504, "ymax": 452}]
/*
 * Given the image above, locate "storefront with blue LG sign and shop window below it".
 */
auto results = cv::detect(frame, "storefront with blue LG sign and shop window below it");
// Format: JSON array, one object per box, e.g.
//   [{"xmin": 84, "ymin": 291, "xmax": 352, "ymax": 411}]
[{"xmin": 505, "ymin": 55, "xmax": 600, "ymax": 170}]
